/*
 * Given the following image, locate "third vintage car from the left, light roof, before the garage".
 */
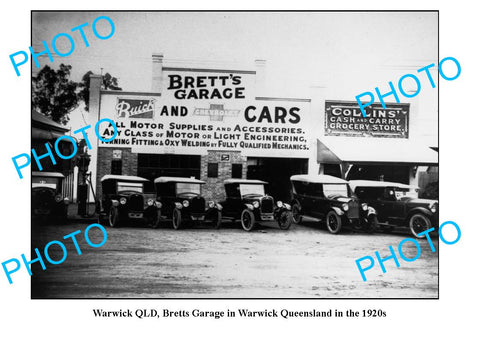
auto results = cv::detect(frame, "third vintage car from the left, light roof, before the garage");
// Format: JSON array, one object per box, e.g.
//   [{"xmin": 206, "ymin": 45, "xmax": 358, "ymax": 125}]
[{"xmin": 154, "ymin": 176, "xmax": 222, "ymax": 229}]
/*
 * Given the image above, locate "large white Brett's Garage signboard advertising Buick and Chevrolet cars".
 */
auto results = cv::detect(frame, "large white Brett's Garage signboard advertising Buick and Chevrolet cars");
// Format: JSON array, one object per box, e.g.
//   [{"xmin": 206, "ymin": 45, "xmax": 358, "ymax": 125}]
[{"xmin": 100, "ymin": 70, "xmax": 310, "ymax": 157}]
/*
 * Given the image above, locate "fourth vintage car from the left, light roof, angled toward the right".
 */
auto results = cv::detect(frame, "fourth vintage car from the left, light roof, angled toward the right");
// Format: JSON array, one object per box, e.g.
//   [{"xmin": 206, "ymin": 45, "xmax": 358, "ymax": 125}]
[{"xmin": 220, "ymin": 179, "xmax": 292, "ymax": 231}]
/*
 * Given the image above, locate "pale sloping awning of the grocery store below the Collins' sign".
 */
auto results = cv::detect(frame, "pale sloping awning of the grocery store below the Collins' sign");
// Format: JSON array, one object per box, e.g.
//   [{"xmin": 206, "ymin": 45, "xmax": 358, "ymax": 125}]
[{"xmin": 317, "ymin": 137, "xmax": 438, "ymax": 165}]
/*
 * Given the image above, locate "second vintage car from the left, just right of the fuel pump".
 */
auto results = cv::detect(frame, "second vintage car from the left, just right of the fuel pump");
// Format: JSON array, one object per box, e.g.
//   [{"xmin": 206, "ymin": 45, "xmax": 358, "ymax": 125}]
[{"xmin": 98, "ymin": 175, "xmax": 161, "ymax": 227}]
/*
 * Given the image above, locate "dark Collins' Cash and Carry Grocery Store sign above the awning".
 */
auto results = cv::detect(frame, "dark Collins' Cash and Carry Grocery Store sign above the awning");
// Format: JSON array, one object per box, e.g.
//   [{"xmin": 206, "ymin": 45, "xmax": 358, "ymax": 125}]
[{"xmin": 325, "ymin": 100, "xmax": 410, "ymax": 138}]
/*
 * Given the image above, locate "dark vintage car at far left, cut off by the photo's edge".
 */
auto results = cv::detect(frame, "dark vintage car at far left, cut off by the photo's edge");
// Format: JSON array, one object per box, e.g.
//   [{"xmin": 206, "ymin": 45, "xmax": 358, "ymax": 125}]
[{"xmin": 32, "ymin": 171, "xmax": 70, "ymax": 220}]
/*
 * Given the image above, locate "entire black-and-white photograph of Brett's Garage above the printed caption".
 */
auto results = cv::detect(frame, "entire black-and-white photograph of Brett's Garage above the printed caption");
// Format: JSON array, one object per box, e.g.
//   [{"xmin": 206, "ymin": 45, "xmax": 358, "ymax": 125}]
[{"xmin": 27, "ymin": 10, "xmax": 438, "ymax": 299}]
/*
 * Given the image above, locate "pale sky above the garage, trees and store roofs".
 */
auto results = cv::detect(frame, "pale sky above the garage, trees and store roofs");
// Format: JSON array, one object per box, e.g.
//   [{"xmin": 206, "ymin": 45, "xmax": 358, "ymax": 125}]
[{"xmin": 32, "ymin": 12, "xmax": 438, "ymax": 141}]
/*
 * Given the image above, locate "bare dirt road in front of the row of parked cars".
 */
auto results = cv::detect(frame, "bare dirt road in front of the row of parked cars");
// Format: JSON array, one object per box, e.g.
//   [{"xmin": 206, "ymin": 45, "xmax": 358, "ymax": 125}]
[{"xmin": 32, "ymin": 222, "xmax": 438, "ymax": 298}]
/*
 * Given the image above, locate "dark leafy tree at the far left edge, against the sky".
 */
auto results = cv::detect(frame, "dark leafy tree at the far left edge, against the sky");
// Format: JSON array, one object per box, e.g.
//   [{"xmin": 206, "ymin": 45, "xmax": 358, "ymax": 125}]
[{"xmin": 32, "ymin": 64, "xmax": 78, "ymax": 125}]
